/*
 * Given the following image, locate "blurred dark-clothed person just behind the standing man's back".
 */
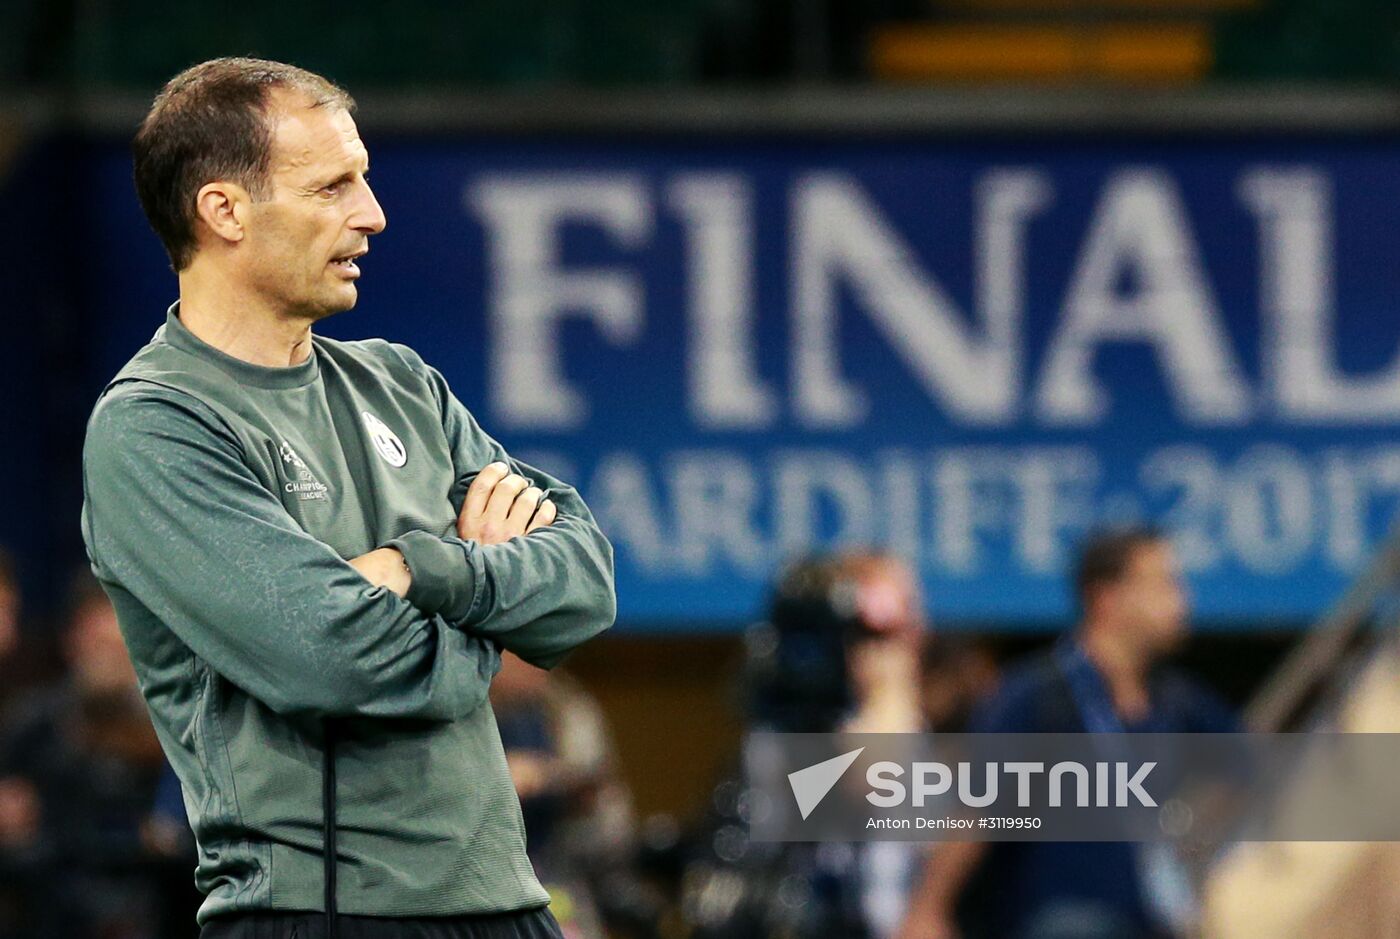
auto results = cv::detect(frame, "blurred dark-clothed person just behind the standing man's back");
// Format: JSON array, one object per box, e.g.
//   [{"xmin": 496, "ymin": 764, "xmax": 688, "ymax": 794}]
[{"xmin": 0, "ymin": 571, "xmax": 172, "ymax": 939}]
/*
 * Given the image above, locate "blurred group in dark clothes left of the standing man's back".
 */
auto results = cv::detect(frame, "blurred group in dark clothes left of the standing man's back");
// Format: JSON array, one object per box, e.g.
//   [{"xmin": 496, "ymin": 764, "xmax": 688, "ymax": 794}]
[{"xmin": 0, "ymin": 557, "xmax": 199, "ymax": 939}]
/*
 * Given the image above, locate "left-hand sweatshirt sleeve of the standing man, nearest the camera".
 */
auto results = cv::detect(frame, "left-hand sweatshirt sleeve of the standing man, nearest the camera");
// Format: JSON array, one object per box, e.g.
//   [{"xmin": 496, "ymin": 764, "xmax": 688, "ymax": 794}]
[{"xmin": 83, "ymin": 385, "xmax": 500, "ymax": 719}]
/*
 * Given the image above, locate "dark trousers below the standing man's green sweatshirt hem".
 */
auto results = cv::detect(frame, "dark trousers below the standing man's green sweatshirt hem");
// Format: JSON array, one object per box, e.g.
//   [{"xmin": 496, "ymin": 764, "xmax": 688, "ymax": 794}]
[{"xmin": 199, "ymin": 907, "xmax": 563, "ymax": 939}]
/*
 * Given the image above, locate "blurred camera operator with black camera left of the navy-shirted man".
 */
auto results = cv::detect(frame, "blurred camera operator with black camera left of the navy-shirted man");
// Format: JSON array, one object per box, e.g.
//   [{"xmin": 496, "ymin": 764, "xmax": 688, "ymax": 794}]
[{"xmin": 683, "ymin": 553, "xmax": 927, "ymax": 939}]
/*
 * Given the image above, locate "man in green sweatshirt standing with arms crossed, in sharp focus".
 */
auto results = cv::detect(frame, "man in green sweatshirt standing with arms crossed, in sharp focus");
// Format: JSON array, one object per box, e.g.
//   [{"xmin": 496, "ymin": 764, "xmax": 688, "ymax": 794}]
[{"xmin": 83, "ymin": 59, "xmax": 616, "ymax": 939}]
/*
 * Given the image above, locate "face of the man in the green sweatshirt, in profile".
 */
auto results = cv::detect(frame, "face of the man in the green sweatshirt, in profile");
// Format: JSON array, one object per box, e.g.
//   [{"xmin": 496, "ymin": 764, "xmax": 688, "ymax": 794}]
[{"xmin": 242, "ymin": 94, "xmax": 385, "ymax": 320}]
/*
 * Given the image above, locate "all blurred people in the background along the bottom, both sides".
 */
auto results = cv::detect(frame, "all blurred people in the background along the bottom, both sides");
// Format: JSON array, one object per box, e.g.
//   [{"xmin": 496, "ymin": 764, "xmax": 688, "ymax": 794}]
[{"xmin": 0, "ymin": 529, "xmax": 1233, "ymax": 939}]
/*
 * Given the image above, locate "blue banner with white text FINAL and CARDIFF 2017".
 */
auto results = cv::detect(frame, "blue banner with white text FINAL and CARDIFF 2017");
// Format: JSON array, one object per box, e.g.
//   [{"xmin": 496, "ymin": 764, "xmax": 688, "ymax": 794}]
[{"xmin": 87, "ymin": 137, "xmax": 1400, "ymax": 628}]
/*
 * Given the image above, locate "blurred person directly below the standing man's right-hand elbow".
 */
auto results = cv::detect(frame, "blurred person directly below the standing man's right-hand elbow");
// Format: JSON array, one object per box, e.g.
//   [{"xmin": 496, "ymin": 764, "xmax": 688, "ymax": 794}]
[{"xmin": 491, "ymin": 654, "xmax": 659, "ymax": 939}]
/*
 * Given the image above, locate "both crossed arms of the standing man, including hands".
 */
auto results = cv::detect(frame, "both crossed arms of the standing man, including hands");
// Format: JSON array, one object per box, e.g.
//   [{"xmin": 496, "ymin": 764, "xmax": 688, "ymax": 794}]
[{"xmin": 83, "ymin": 383, "xmax": 615, "ymax": 719}]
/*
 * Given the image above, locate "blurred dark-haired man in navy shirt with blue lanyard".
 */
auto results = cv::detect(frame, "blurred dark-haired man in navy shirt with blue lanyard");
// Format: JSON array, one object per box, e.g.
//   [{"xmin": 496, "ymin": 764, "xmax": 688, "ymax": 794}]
[{"xmin": 900, "ymin": 528, "xmax": 1238, "ymax": 939}]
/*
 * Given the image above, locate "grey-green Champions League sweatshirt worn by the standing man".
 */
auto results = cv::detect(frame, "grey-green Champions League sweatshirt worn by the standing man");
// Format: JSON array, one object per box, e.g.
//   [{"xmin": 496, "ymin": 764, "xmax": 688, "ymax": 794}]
[{"xmin": 83, "ymin": 305, "xmax": 616, "ymax": 924}]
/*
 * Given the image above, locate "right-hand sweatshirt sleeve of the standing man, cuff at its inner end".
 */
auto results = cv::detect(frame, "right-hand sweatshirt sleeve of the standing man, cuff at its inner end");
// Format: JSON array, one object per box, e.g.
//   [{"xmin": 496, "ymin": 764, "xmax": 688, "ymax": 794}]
[{"xmin": 389, "ymin": 346, "xmax": 617, "ymax": 668}]
